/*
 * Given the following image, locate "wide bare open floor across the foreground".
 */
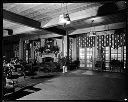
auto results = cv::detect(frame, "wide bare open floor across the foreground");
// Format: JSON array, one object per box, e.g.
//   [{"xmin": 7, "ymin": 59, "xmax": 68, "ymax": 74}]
[{"xmin": 3, "ymin": 69, "xmax": 126, "ymax": 100}]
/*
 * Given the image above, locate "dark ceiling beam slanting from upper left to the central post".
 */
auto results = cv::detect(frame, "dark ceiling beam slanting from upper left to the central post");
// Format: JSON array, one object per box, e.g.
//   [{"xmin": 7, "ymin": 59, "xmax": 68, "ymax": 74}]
[{"xmin": 3, "ymin": 9, "xmax": 66, "ymax": 35}]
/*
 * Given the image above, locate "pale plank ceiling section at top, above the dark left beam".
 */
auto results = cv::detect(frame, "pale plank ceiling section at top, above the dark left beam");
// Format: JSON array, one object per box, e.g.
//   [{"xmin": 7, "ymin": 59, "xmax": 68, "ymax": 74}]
[{"xmin": 3, "ymin": 3, "xmax": 94, "ymax": 22}]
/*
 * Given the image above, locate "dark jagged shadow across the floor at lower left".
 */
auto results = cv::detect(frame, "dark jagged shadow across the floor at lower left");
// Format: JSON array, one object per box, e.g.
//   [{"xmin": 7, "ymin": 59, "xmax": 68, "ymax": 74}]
[{"xmin": 3, "ymin": 74, "xmax": 59, "ymax": 101}]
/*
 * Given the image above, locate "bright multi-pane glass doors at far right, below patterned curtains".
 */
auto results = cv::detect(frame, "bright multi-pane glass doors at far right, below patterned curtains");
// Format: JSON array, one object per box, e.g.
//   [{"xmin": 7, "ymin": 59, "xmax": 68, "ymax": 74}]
[{"xmin": 103, "ymin": 46, "xmax": 126, "ymax": 72}]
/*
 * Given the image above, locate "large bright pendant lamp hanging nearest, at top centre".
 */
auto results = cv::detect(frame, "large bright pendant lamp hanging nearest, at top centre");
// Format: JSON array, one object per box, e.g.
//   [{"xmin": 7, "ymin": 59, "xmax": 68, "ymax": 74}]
[{"xmin": 59, "ymin": 3, "xmax": 71, "ymax": 25}]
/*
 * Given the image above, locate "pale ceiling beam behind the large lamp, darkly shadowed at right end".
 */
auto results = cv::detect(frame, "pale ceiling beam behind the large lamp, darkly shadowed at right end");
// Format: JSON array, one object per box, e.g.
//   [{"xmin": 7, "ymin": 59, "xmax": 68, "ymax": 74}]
[{"xmin": 41, "ymin": 2, "xmax": 126, "ymax": 28}]
